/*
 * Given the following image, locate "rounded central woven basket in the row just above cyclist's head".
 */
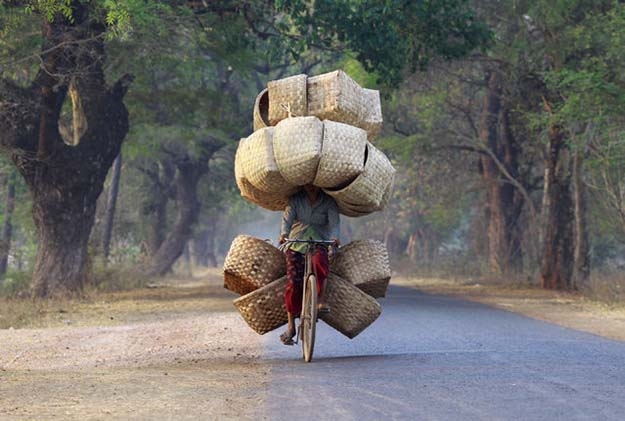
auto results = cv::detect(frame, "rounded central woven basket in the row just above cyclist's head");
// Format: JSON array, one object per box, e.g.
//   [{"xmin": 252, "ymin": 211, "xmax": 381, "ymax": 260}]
[{"xmin": 273, "ymin": 117, "xmax": 323, "ymax": 186}]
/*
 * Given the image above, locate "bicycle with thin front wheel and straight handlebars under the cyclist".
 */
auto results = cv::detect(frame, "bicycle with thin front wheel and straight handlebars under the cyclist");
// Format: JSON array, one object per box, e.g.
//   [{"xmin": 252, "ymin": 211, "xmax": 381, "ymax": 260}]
[{"xmin": 284, "ymin": 238, "xmax": 334, "ymax": 363}]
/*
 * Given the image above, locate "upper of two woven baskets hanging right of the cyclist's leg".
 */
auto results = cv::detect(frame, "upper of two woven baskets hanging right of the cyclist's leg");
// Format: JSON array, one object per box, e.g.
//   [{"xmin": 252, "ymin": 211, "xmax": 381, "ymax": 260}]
[{"xmin": 330, "ymin": 240, "xmax": 391, "ymax": 298}]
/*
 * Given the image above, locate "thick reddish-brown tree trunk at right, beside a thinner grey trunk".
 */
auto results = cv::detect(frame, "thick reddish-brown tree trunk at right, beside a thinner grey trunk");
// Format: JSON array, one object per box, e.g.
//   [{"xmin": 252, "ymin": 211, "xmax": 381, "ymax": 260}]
[{"xmin": 540, "ymin": 126, "xmax": 575, "ymax": 289}]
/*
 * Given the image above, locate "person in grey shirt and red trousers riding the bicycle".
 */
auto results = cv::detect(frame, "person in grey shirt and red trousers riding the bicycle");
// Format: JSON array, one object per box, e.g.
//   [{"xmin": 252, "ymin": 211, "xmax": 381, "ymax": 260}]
[{"xmin": 278, "ymin": 184, "xmax": 340, "ymax": 345}]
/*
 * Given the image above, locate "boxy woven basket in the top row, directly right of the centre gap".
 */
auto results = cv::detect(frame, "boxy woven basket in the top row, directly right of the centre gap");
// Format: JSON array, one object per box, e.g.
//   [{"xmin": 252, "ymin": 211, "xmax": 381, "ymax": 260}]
[{"xmin": 306, "ymin": 70, "xmax": 367, "ymax": 127}]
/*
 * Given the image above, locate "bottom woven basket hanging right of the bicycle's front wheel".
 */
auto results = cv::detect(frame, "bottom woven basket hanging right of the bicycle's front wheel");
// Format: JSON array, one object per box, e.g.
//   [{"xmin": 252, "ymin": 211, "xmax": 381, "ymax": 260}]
[{"xmin": 319, "ymin": 273, "xmax": 382, "ymax": 339}]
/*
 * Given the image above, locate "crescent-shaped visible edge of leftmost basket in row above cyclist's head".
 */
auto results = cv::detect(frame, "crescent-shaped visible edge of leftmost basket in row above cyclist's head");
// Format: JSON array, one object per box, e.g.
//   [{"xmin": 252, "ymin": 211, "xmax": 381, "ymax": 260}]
[{"xmin": 234, "ymin": 138, "xmax": 291, "ymax": 211}]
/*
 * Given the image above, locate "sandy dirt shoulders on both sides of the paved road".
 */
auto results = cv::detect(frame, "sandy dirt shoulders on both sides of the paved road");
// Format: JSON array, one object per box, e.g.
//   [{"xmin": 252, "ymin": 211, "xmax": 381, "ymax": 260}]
[{"xmin": 0, "ymin": 270, "xmax": 625, "ymax": 420}]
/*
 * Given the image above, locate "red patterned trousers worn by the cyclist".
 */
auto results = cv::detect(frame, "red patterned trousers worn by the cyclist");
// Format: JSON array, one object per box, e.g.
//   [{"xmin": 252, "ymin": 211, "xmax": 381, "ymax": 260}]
[{"xmin": 284, "ymin": 246, "xmax": 329, "ymax": 315}]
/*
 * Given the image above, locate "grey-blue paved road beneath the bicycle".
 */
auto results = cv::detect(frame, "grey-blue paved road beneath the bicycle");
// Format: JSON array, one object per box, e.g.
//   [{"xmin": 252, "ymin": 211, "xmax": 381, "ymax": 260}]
[{"xmin": 258, "ymin": 286, "xmax": 625, "ymax": 421}]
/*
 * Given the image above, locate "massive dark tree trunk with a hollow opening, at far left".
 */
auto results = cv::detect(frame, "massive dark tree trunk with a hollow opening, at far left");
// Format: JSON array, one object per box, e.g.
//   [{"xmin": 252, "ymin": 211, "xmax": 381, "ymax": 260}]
[{"xmin": 0, "ymin": 6, "xmax": 131, "ymax": 297}]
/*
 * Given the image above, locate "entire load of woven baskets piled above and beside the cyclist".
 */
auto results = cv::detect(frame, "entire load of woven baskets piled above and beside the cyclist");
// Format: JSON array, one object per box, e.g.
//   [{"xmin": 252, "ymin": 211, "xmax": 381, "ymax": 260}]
[{"xmin": 224, "ymin": 70, "xmax": 395, "ymax": 338}]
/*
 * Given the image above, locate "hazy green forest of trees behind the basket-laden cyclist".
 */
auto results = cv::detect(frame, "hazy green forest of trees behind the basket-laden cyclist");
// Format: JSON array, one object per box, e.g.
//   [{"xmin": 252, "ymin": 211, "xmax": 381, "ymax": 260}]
[{"xmin": 0, "ymin": 0, "xmax": 625, "ymax": 302}]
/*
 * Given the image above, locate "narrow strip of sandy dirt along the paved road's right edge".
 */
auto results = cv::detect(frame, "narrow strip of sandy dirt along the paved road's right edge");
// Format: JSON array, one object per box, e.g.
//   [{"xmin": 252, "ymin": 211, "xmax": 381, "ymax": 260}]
[{"xmin": 391, "ymin": 276, "xmax": 625, "ymax": 341}]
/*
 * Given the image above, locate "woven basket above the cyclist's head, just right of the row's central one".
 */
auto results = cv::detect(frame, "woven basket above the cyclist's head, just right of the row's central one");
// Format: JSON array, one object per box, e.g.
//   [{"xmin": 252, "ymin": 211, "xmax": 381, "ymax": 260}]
[{"xmin": 313, "ymin": 120, "xmax": 367, "ymax": 188}]
